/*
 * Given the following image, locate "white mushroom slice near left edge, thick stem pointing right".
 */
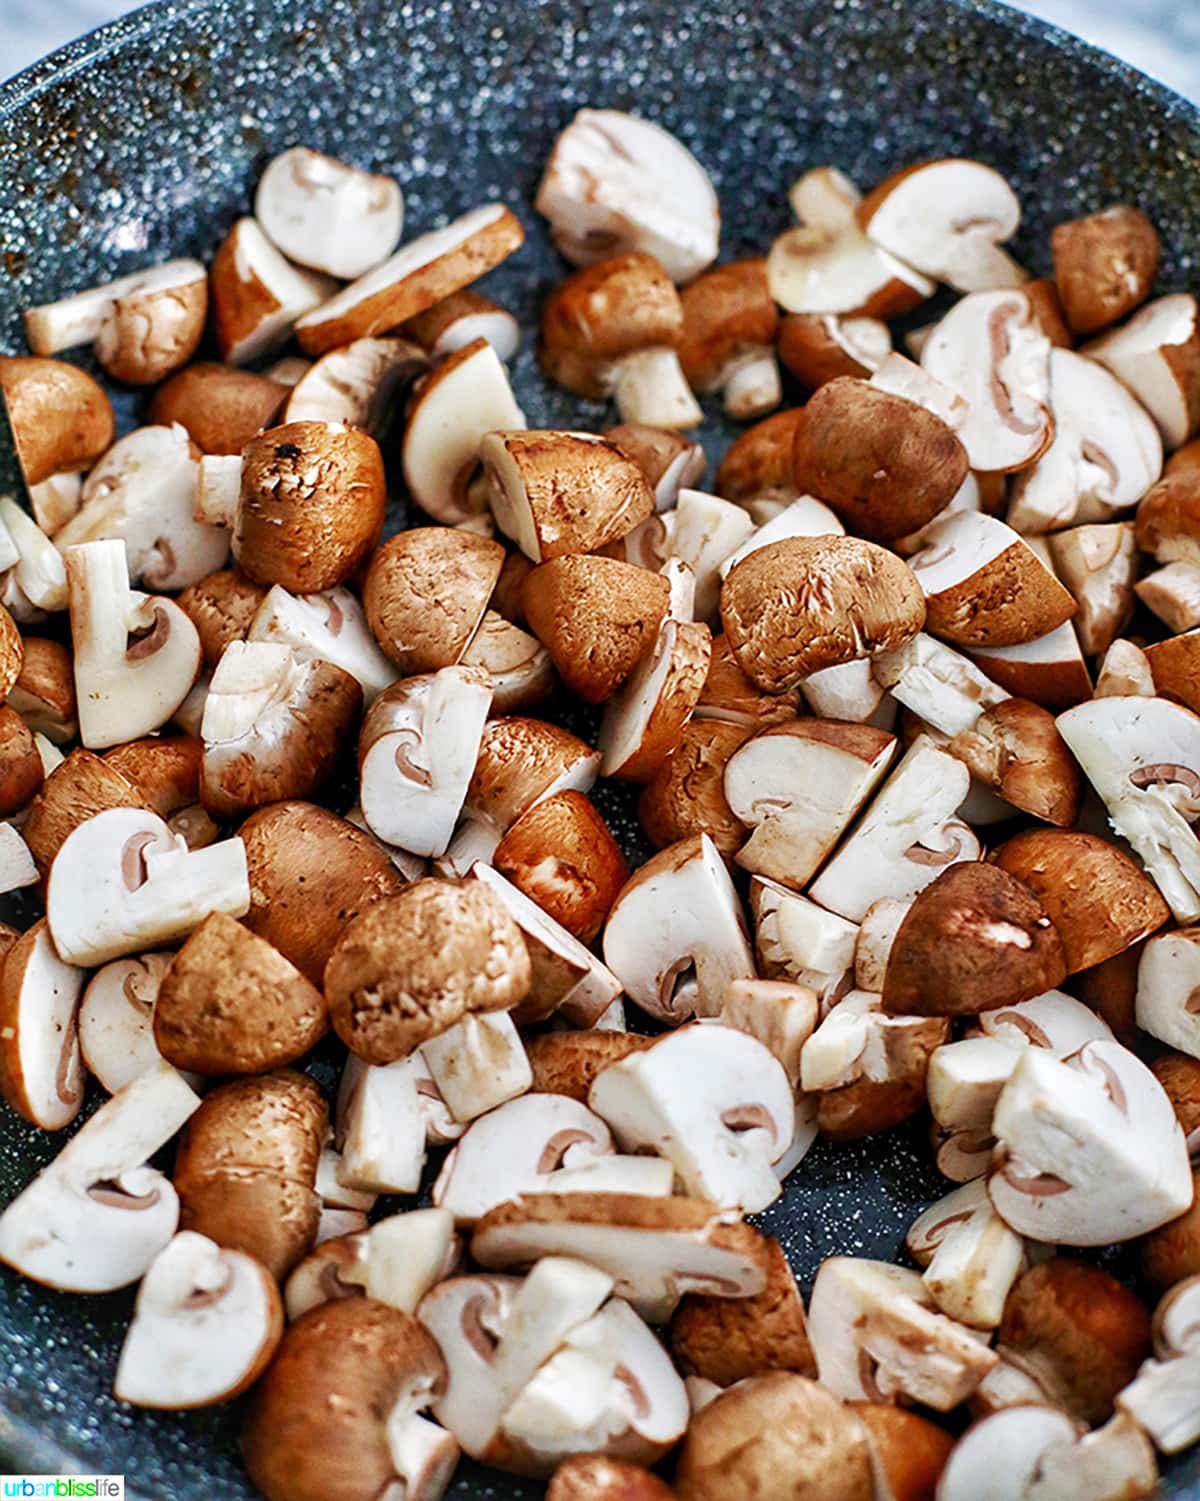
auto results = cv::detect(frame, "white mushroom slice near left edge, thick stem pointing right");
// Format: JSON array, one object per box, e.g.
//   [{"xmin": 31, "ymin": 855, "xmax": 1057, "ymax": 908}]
[{"xmin": 47, "ymin": 808, "xmax": 249, "ymax": 965}]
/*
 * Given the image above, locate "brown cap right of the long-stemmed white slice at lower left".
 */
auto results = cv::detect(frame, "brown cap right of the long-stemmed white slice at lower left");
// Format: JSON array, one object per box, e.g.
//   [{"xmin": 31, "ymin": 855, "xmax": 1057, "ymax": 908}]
[{"xmin": 171, "ymin": 1069, "xmax": 329, "ymax": 1279}]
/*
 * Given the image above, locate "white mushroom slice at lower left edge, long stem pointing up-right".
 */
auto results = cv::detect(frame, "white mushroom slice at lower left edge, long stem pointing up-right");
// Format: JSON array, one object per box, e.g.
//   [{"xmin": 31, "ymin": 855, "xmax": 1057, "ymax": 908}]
[{"xmin": 0, "ymin": 1063, "xmax": 200, "ymax": 1292}]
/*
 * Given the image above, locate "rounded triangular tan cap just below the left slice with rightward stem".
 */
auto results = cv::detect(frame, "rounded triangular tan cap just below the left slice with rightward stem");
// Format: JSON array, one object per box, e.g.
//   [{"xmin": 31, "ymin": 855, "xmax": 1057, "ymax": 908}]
[{"xmin": 155, "ymin": 913, "xmax": 329, "ymax": 1075}]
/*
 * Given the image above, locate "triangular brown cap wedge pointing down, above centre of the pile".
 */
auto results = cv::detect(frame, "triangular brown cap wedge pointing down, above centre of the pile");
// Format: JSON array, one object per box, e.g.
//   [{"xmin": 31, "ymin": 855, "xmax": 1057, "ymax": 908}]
[{"xmin": 521, "ymin": 554, "xmax": 670, "ymax": 704}]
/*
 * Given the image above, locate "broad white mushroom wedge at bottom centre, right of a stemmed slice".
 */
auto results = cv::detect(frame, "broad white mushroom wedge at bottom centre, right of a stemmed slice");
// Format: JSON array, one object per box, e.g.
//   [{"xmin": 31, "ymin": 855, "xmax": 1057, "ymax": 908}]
[{"xmin": 502, "ymin": 1298, "xmax": 689, "ymax": 1472}]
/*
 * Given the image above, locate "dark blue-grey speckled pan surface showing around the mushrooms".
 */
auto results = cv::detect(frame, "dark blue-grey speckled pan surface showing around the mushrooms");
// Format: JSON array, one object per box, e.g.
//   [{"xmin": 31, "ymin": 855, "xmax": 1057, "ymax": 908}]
[{"xmin": 0, "ymin": 0, "xmax": 1200, "ymax": 1501}]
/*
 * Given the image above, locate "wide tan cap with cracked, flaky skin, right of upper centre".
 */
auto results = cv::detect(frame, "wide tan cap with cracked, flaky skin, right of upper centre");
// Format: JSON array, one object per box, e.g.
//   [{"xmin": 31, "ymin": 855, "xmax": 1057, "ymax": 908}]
[{"xmin": 721, "ymin": 537, "xmax": 925, "ymax": 693}]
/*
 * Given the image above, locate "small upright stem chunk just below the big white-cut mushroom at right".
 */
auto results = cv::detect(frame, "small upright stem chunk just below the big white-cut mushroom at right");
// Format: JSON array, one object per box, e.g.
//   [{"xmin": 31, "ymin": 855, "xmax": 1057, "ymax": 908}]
[{"xmin": 907, "ymin": 1178, "xmax": 1026, "ymax": 1328}]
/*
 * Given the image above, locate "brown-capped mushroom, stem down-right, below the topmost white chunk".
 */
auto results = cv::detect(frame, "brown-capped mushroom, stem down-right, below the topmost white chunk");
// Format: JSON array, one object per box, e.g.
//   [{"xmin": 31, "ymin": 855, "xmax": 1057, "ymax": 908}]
[{"xmin": 538, "ymin": 251, "xmax": 701, "ymax": 428}]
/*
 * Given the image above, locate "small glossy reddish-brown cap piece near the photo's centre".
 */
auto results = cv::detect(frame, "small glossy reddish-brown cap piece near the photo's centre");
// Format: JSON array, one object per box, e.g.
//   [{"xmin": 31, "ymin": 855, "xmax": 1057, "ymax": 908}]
[{"xmin": 493, "ymin": 791, "xmax": 629, "ymax": 944}]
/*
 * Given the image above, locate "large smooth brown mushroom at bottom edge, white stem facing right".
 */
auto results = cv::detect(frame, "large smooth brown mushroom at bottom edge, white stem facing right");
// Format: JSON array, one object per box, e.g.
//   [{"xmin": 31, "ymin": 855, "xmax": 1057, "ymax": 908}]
[{"xmin": 242, "ymin": 1298, "xmax": 458, "ymax": 1501}]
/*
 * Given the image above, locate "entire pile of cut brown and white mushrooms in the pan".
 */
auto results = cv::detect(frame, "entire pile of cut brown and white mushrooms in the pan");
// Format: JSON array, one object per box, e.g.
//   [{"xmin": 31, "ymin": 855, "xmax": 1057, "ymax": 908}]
[{"xmin": 0, "ymin": 110, "xmax": 1200, "ymax": 1501}]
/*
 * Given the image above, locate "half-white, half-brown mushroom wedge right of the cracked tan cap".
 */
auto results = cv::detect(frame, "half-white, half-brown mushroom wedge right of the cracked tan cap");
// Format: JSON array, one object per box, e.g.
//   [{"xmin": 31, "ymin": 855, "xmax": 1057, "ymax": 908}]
[{"xmin": 909, "ymin": 510, "xmax": 1075, "ymax": 647}]
